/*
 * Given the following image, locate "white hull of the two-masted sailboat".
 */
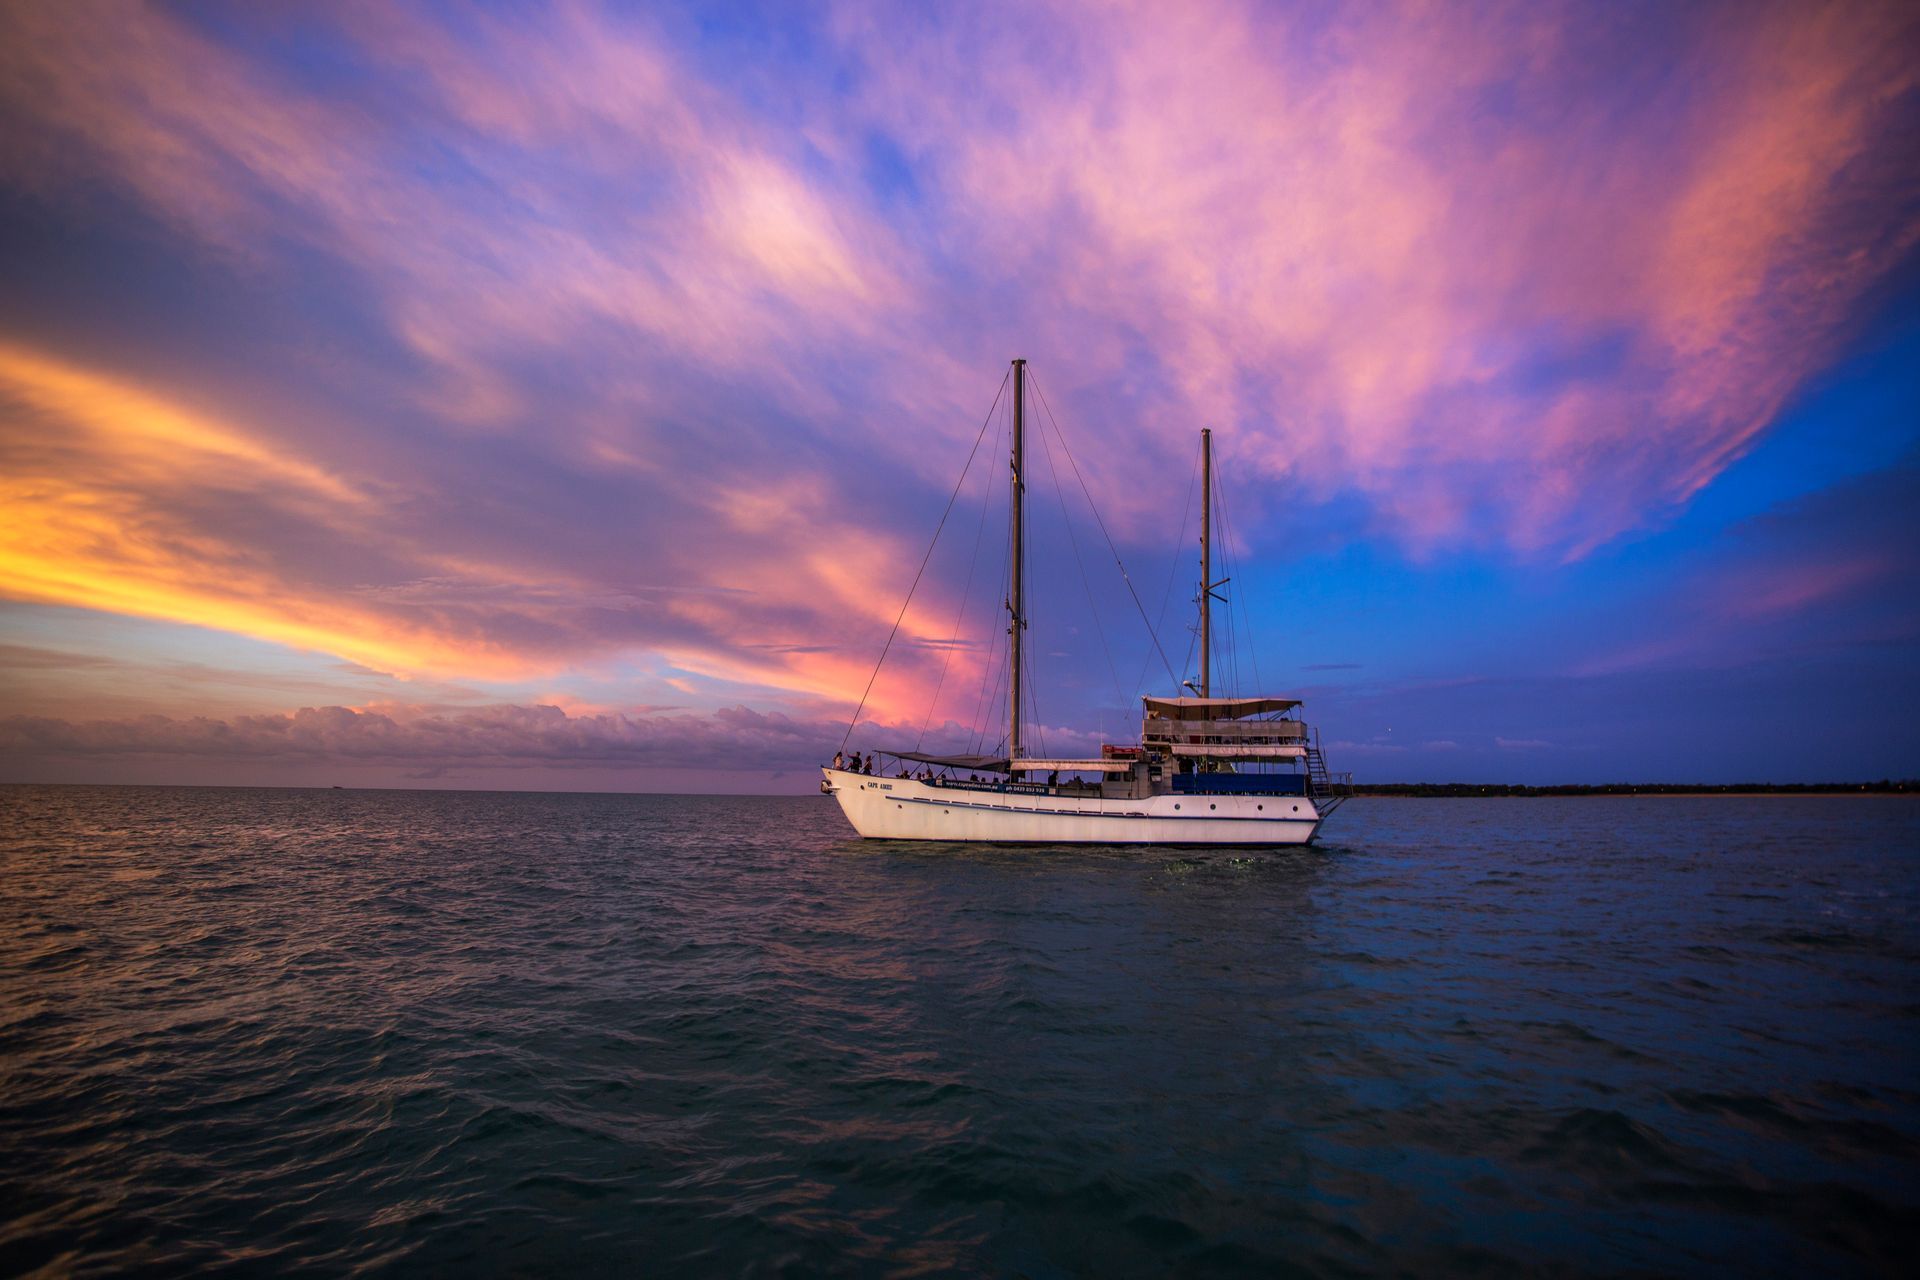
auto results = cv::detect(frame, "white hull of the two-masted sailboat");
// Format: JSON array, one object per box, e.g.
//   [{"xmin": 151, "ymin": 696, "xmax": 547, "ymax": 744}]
[{"xmin": 820, "ymin": 770, "xmax": 1321, "ymax": 846}]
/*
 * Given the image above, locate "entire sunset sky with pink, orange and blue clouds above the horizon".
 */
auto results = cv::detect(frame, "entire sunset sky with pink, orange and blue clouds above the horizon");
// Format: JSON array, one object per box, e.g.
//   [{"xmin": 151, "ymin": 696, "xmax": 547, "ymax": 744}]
[{"xmin": 0, "ymin": 0, "xmax": 1920, "ymax": 791}]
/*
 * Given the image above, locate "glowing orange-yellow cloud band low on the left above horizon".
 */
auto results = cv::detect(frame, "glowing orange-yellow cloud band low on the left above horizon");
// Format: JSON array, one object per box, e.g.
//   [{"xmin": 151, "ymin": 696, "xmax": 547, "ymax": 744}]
[{"xmin": 0, "ymin": 345, "xmax": 967, "ymax": 714}]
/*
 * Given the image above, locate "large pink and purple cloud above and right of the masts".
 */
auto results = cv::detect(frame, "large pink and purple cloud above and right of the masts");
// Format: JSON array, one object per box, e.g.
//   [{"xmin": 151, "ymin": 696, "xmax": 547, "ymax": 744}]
[{"xmin": 845, "ymin": 4, "xmax": 1920, "ymax": 555}]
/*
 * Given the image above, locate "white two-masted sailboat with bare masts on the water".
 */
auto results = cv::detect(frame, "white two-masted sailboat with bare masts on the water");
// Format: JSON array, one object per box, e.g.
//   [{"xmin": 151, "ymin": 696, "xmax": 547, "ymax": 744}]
[{"xmin": 820, "ymin": 361, "xmax": 1352, "ymax": 846}]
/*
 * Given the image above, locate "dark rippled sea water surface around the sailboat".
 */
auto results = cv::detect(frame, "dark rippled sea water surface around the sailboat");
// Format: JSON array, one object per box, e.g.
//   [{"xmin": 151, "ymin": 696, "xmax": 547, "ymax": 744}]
[{"xmin": 0, "ymin": 787, "xmax": 1920, "ymax": 1276}]
